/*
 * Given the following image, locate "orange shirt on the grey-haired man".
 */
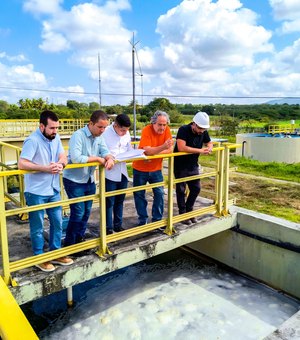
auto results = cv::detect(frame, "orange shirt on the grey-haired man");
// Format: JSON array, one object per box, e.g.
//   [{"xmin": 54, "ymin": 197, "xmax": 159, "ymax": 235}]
[{"xmin": 132, "ymin": 124, "xmax": 172, "ymax": 172}]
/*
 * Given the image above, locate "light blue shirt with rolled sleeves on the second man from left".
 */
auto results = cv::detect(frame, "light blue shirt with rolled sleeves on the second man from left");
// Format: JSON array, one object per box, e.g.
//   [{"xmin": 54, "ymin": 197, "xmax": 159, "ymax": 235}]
[{"xmin": 63, "ymin": 125, "xmax": 110, "ymax": 183}]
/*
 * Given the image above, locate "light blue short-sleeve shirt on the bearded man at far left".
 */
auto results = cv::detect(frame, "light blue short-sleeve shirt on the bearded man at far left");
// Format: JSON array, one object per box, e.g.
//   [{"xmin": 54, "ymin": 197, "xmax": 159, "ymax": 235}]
[{"xmin": 20, "ymin": 129, "xmax": 64, "ymax": 196}]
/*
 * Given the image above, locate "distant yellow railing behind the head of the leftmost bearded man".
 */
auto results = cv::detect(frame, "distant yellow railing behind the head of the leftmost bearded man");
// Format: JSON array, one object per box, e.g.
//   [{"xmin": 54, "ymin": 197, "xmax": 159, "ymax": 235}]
[{"xmin": 0, "ymin": 119, "xmax": 88, "ymax": 138}]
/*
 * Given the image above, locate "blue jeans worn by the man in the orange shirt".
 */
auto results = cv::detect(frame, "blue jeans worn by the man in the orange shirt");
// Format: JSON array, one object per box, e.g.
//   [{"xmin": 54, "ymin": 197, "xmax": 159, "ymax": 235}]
[{"xmin": 133, "ymin": 169, "xmax": 164, "ymax": 225}]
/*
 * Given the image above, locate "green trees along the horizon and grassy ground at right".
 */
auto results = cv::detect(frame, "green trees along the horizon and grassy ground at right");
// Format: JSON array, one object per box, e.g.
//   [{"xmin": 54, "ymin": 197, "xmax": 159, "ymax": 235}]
[{"xmin": 0, "ymin": 98, "xmax": 300, "ymax": 222}]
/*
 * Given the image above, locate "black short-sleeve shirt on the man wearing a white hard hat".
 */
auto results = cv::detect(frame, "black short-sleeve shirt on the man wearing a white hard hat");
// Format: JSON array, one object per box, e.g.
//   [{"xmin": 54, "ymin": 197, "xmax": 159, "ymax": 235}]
[{"xmin": 174, "ymin": 123, "xmax": 211, "ymax": 171}]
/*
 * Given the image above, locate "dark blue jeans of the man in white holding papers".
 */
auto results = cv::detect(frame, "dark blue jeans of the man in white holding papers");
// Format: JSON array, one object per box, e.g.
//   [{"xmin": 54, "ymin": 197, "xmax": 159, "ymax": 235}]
[{"xmin": 105, "ymin": 175, "xmax": 128, "ymax": 231}]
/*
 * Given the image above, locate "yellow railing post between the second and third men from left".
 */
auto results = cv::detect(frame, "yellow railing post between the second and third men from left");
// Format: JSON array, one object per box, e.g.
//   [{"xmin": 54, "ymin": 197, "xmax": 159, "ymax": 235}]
[{"xmin": 97, "ymin": 165, "xmax": 109, "ymax": 257}]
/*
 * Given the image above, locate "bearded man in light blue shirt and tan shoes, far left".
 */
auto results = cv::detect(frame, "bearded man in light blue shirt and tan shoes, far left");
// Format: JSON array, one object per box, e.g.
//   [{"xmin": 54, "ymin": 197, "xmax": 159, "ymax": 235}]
[{"xmin": 18, "ymin": 110, "xmax": 73, "ymax": 272}]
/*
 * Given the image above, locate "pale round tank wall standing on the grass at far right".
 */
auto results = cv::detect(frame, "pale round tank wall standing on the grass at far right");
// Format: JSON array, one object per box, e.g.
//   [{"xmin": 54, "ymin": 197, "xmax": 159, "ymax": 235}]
[{"xmin": 236, "ymin": 134, "xmax": 300, "ymax": 164}]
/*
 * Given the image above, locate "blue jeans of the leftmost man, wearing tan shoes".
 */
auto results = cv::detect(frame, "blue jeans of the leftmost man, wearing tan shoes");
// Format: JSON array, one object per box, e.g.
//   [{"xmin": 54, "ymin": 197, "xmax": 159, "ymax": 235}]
[{"xmin": 24, "ymin": 190, "xmax": 62, "ymax": 255}]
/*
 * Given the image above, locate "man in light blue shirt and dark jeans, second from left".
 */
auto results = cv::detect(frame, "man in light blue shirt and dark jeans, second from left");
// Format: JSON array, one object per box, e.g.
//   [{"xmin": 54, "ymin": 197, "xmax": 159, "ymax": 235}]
[{"xmin": 63, "ymin": 110, "xmax": 114, "ymax": 246}]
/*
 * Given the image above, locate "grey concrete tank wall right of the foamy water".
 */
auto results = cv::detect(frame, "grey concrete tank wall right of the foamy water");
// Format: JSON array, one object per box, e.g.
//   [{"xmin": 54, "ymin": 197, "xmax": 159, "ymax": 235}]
[{"xmin": 189, "ymin": 209, "xmax": 300, "ymax": 298}]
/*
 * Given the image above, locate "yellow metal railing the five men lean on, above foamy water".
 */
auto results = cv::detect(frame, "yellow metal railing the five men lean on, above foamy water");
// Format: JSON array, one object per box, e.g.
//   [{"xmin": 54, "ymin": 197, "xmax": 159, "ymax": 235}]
[{"xmin": 0, "ymin": 143, "xmax": 241, "ymax": 339}]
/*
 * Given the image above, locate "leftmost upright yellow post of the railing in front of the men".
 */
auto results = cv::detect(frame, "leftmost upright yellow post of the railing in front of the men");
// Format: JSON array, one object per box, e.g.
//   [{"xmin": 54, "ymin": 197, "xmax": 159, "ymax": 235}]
[{"xmin": 0, "ymin": 177, "xmax": 10, "ymax": 285}]
